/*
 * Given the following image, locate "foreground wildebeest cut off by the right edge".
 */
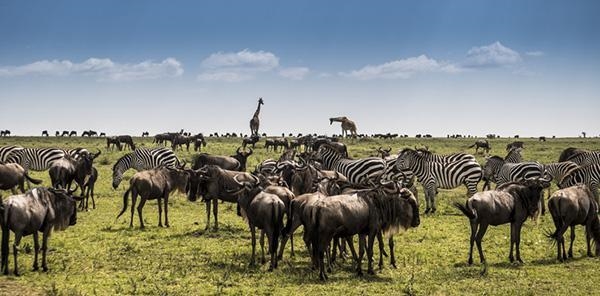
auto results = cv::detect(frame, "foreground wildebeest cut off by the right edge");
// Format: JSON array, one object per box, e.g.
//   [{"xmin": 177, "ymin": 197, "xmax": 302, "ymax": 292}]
[{"xmin": 548, "ymin": 184, "xmax": 600, "ymax": 261}]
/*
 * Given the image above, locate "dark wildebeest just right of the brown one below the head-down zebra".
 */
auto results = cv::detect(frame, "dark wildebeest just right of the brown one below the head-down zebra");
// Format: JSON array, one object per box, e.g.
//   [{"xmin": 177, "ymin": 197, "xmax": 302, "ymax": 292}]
[{"xmin": 186, "ymin": 165, "xmax": 259, "ymax": 229}]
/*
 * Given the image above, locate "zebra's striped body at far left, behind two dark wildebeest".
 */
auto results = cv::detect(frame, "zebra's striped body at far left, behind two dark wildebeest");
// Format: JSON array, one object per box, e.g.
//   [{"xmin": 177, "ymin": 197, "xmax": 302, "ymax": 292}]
[{"xmin": 6, "ymin": 148, "xmax": 65, "ymax": 172}]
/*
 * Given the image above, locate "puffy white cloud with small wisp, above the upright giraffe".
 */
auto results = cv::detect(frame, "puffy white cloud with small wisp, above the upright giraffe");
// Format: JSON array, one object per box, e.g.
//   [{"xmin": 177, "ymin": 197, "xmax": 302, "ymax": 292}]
[{"xmin": 198, "ymin": 49, "xmax": 310, "ymax": 82}]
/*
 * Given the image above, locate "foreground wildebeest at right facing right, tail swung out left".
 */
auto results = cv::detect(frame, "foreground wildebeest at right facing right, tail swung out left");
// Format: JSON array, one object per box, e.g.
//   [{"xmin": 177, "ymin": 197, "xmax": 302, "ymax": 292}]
[{"xmin": 454, "ymin": 179, "xmax": 550, "ymax": 273}]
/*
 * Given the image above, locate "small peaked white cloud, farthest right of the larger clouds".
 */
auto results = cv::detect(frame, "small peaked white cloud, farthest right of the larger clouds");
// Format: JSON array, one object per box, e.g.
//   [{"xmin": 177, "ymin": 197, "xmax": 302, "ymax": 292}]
[{"xmin": 464, "ymin": 41, "xmax": 521, "ymax": 67}]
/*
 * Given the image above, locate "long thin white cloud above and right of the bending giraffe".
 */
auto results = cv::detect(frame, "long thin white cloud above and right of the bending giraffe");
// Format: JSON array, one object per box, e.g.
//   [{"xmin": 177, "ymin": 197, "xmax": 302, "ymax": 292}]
[{"xmin": 339, "ymin": 55, "xmax": 462, "ymax": 80}]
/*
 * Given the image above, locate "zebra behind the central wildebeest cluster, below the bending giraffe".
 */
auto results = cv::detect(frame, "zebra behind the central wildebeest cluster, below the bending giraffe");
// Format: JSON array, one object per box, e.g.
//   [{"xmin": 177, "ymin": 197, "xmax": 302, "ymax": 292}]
[{"xmin": 317, "ymin": 144, "xmax": 386, "ymax": 185}]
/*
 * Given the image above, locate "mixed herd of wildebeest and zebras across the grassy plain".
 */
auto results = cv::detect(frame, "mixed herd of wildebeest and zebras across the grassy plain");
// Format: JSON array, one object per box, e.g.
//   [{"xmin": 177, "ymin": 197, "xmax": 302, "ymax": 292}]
[{"xmin": 0, "ymin": 130, "xmax": 600, "ymax": 279}]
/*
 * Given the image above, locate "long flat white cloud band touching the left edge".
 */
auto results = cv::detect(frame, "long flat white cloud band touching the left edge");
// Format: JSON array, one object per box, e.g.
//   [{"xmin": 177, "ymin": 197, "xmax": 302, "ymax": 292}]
[{"xmin": 0, "ymin": 58, "xmax": 183, "ymax": 81}]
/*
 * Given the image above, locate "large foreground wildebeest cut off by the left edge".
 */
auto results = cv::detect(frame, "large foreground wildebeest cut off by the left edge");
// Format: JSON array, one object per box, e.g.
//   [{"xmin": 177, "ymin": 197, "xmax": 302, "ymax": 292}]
[{"xmin": 0, "ymin": 188, "xmax": 81, "ymax": 275}]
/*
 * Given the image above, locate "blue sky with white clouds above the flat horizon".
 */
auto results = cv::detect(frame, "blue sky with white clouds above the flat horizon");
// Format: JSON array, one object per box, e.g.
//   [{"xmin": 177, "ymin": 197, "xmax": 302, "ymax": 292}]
[{"xmin": 0, "ymin": 1, "xmax": 600, "ymax": 136}]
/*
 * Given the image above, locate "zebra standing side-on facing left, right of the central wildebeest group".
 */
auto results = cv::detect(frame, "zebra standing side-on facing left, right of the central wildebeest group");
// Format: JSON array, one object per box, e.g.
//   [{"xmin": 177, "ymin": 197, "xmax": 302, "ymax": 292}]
[{"xmin": 396, "ymin": 148, "xmax": 482, "ymax": 213}]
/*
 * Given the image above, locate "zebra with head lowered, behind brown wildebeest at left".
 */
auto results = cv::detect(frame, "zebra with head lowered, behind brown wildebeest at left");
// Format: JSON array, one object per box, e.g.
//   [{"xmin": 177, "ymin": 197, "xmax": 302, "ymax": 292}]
[{"xmin": 113, "ymin": 148, "xmax": 180, "ymax": 189}]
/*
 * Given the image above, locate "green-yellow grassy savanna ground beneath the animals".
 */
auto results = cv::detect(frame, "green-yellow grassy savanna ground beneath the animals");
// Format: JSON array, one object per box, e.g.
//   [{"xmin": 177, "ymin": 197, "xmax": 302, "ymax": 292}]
[{"xmin": 0, "ymin": 137, "xmax": 600, "ymax": 295}]
